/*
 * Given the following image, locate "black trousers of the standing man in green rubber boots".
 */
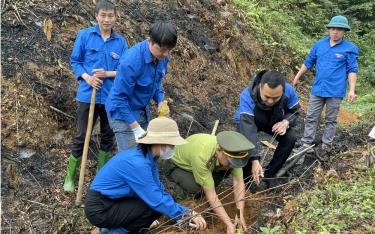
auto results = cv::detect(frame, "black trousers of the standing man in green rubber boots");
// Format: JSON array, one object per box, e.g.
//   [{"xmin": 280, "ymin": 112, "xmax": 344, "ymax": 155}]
[{"xmin": 71, "ymin": 102, "xmax": 114, "ymax": 158}]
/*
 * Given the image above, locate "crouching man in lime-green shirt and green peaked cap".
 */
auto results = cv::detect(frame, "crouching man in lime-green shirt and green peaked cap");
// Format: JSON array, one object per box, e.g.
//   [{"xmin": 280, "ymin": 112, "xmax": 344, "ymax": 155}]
[{"xmin": 165, "ymin": 131, "xmax": 254, "ymax": 233}]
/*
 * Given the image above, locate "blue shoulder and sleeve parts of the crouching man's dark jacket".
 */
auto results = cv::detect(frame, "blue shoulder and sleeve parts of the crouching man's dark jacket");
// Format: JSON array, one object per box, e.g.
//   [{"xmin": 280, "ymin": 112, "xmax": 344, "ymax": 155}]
[{"xmin": 234, "ymin": 83, "xmax": 299, "ymax": 124}]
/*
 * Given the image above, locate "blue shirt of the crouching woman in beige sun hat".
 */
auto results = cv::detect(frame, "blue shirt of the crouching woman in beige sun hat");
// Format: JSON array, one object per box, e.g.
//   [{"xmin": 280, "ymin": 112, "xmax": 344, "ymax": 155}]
[{"xmin": 90, "ymin": 147, "xmax": 189, "ymax": 220}]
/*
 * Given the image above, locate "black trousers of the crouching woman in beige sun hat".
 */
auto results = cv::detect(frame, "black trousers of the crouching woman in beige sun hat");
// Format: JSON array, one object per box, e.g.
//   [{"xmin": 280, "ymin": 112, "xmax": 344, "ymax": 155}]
[{"xmin": 85, "ymin": 189, "xmax": 161, "ymax": 233}]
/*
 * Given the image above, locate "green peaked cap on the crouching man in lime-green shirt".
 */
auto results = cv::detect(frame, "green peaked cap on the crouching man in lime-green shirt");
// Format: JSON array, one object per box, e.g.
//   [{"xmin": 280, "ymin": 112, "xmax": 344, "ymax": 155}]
[{"xmin": 217, "ymin": 131, "xmax": 254, "ymax": 168}]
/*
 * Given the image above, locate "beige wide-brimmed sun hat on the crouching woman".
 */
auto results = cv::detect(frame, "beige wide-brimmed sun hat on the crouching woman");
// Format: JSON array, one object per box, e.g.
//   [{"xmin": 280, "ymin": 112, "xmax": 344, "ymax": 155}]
[{"xmin": 137, "ymin": 117, "xmax": 188, "ymax": 145}]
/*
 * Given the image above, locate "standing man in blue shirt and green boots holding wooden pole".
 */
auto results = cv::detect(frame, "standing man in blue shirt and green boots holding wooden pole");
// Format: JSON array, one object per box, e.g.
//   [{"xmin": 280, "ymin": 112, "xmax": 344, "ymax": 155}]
[{"xmin": 64, "ymin": 0, "xmax": 128, "ymax": 192}]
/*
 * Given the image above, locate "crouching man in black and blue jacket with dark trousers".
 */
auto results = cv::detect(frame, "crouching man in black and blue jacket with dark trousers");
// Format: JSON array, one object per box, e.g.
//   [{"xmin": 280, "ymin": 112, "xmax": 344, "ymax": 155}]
[{"xmin": 235, "ymin": 71, "xmax": 300, "ymax": 187}]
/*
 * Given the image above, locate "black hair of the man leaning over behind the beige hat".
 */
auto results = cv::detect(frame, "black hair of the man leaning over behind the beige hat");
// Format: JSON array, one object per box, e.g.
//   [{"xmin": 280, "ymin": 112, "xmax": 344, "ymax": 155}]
[{"xmin": 149, "ymin": 21, "xmax": 177, "ymax": 49}]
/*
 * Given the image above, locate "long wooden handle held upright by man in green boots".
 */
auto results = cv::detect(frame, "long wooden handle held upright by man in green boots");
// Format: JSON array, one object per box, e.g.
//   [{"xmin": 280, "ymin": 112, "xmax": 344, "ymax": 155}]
[{"xmin": 76, "ymin": 89, "xmax": 96, "ymax": 206}]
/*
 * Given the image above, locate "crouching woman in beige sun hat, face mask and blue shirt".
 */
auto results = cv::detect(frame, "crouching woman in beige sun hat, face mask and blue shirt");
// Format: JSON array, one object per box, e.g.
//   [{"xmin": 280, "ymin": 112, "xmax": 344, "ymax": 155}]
[{"xmin": 85, "ymin": 117, "xmax": 206, "ymax": 233}]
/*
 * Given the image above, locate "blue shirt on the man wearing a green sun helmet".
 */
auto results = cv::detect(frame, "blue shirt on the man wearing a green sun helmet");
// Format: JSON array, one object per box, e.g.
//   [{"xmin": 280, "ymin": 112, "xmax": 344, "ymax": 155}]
[{"xmin": 304, "ymin": 37, "xmax": 359, "ymax": 98}]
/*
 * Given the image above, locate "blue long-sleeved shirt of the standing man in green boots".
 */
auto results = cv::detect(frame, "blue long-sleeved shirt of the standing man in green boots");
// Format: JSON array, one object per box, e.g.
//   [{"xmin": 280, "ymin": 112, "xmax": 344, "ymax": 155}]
[{"xmin": 70, "ymin": 24, "xmax": 128, "ymax": 104}]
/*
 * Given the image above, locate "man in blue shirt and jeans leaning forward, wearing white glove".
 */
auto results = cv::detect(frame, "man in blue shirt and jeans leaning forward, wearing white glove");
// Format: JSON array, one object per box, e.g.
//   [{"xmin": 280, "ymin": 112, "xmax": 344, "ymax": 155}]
[{"xmin": 106, "ymin": 22, "xmax": 177, "ymax": 152}]
